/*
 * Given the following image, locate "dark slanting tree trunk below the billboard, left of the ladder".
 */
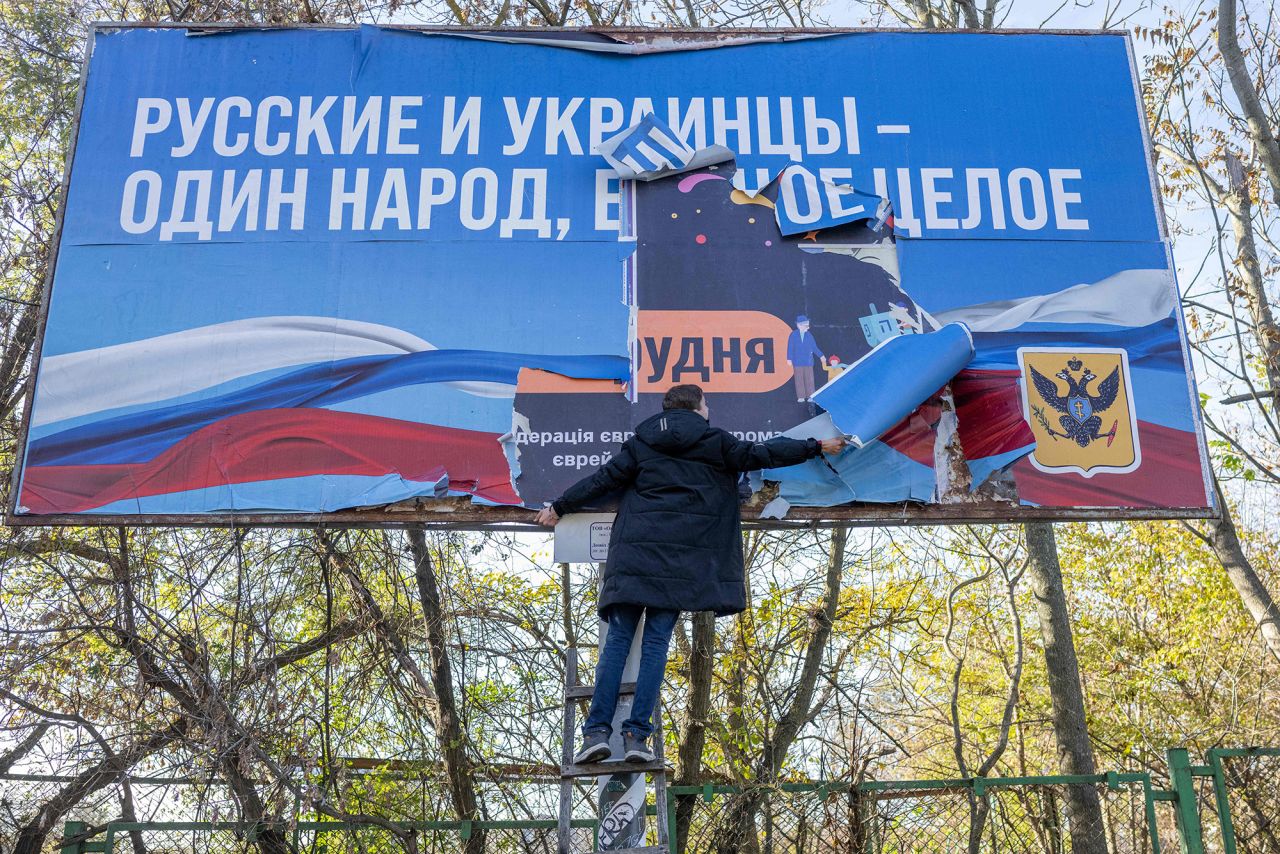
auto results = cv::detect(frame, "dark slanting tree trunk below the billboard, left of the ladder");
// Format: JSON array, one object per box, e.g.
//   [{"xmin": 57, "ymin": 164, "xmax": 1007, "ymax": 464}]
[{"xmin": 408, "ymin": 528, "xmax": 485, "ymax": 854}]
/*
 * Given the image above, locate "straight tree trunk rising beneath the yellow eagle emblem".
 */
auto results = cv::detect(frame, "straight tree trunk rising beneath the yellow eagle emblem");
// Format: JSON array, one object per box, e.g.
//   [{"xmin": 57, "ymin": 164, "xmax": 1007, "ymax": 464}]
[{"xmin": 1025, "ymin": 522, "xmax": 1107, "ymax": 854}]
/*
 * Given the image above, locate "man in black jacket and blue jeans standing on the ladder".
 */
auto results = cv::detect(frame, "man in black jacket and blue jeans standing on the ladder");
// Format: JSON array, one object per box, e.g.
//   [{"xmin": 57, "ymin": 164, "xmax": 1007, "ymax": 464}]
[{"xmin": 538, "ymin": 385, "xmax": 845, "ymax": 762}]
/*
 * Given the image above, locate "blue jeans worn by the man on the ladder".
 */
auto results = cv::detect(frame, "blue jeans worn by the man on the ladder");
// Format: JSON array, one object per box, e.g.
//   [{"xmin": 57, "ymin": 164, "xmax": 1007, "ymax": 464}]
[{"xmin": 582, "ymin": 604, "xmax": 680, "ymax": 739}]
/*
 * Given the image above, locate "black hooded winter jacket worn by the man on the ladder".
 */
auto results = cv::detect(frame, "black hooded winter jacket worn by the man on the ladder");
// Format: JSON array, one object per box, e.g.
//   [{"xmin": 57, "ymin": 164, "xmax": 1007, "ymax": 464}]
[{"xmin": 552, "ymin": 410, "xmax": 822, "ymax": 617}]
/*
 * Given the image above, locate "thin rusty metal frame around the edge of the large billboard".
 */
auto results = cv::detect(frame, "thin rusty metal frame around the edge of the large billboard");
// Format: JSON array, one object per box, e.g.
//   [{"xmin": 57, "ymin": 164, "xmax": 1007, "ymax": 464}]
[{"xmin": 4, "ymin": 20, "xmax": 1221, "ymax": 530}]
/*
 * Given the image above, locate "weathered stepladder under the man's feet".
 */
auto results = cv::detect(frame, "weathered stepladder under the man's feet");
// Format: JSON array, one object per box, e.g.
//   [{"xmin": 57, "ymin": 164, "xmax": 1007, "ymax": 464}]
[{"xmin": 557, "ymin": 647, "xmax": 671, "ymax": 854}]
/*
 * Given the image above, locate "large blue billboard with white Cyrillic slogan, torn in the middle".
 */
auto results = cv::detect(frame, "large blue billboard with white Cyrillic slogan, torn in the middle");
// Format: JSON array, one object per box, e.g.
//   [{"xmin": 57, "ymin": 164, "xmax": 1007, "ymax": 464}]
[{"xmin": 10, "ymin": 26, "xmax": 1212, "ymax": 524}]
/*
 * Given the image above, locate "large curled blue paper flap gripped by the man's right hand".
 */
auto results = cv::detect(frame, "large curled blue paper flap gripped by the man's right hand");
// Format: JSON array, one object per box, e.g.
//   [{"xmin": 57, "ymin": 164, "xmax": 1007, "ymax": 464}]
[{"xmin": 813, "ymin": 323, "xmax": 973, "ymax": 446}]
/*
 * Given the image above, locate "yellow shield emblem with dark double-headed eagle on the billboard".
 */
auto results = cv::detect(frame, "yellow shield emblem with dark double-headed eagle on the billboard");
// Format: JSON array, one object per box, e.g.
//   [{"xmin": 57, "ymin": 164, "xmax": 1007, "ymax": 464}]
[{"xmin": 1018, "ymin": 347, "xmax": 1142, "ymax": 478}]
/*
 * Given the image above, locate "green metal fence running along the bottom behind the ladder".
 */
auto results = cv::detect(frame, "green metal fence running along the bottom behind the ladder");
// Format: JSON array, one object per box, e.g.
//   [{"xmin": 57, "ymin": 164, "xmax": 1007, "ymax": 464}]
[{"xmin": 45, "ymin": 748, "xmax": 1280, "ymax": 854}]
